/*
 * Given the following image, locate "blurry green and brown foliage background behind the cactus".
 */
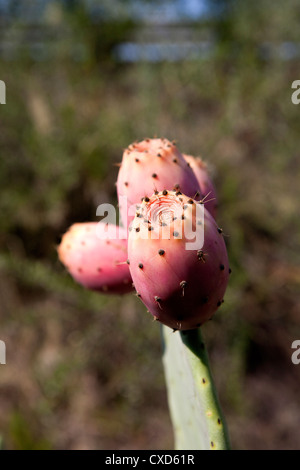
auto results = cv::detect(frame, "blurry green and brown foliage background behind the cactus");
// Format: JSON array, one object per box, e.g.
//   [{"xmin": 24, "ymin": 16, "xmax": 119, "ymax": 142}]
[{"xmin": 0, "ymin": 0, "xmax": 300, "ymax": 449}]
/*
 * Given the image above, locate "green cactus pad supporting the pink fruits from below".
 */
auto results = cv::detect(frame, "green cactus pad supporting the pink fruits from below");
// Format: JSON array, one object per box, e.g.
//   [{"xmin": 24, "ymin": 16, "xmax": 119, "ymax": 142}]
[{"xmin": 162, "ymin": 326, "xmax": 229, "ymax": 450}]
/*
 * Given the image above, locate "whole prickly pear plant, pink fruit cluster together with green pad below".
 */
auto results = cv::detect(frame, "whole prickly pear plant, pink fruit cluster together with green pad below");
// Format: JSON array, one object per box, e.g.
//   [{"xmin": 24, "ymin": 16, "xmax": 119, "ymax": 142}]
[{"xmin": 58, "ymin": 138, "xmax": 231, "ymax": 449}]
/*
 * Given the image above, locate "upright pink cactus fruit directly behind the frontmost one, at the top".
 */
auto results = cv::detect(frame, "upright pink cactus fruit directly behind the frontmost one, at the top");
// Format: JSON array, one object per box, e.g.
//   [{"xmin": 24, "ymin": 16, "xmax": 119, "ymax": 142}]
[{"xmin": 117, "ymin": 139, "xmax": 201, "ymax": 227}]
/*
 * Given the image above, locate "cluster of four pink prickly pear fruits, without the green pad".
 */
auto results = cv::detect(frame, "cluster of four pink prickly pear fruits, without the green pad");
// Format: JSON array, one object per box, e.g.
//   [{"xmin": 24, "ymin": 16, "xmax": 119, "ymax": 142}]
[{"xmin": 58, "ymin": 138, "xmax": 230, "ymax": 330}]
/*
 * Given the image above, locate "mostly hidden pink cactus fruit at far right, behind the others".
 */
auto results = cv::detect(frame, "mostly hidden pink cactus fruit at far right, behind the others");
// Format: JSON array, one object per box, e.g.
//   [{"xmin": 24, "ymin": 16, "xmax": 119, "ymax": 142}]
[{"xmin": 183, "ymin": 154, "xmax": 217, "ymax": 218}]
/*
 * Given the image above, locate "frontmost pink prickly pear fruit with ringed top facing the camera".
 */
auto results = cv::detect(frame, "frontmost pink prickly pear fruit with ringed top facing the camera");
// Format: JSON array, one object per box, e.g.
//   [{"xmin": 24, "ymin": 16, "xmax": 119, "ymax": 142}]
[{"xmin": 128, "ymin": 191, "xmax": 230, "ymax": 330}]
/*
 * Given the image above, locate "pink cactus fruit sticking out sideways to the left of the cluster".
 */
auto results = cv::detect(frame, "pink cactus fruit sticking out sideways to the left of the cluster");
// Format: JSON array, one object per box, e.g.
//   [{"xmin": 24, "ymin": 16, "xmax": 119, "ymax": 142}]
[{"xmin": 58, "ymin": 222, "xmax": 133, "ymax": 294}]
